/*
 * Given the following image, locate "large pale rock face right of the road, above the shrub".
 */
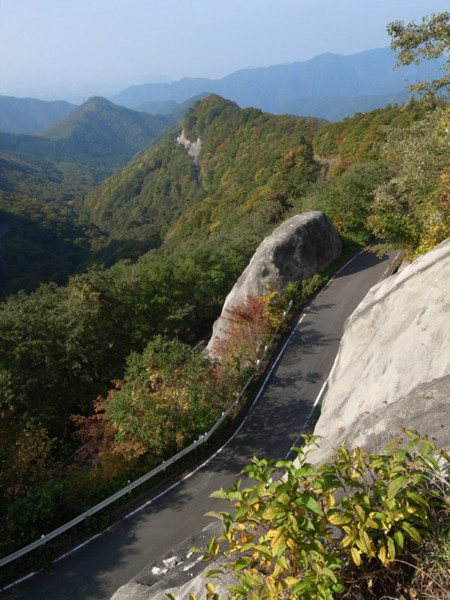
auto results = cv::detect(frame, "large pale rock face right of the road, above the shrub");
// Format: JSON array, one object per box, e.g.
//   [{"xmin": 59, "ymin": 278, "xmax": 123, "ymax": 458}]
[{"xmin": 310, "ymin": 238, "xmax": 450, "ymax": 463}]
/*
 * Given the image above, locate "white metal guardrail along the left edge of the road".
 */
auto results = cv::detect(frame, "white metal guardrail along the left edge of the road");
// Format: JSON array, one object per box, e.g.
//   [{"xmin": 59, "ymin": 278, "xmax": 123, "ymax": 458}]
[{"xmin": 0, "ymin": 300, "xmax": 292, "ymax": 567}]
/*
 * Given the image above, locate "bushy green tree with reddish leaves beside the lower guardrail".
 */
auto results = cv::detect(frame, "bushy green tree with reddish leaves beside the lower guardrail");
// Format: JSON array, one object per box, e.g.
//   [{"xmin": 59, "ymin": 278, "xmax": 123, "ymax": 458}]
[{"xmin": 72, "ymin": 336, "xmax": 228, "ymax": 470}]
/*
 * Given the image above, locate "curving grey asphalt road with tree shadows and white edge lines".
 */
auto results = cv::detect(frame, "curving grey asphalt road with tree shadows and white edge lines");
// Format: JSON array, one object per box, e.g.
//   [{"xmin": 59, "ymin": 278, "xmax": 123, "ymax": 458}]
[{"xmin": 0, "ymin": 246, "xmax": 398, "ymax": 600}]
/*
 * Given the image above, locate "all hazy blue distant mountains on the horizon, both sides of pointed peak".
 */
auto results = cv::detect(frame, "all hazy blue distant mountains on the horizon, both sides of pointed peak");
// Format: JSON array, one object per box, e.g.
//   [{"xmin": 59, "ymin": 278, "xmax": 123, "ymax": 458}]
[{"xmin": 0, "ymin": 48, "xmax": 442, "ymax": 133}]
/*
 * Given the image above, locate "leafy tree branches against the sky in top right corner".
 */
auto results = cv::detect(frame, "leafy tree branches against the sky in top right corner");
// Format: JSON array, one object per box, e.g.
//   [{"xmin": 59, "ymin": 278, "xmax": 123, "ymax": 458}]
[{"xmin": 387, "ymin": 12, "xmax": 450, "ymax": 92}]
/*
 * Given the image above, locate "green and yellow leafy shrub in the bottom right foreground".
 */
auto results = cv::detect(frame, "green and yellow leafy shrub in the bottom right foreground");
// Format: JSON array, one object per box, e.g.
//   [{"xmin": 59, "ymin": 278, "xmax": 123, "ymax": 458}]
[{"xmin": 191, "ymin": 432, "xmax": 450, "ymax": 600}]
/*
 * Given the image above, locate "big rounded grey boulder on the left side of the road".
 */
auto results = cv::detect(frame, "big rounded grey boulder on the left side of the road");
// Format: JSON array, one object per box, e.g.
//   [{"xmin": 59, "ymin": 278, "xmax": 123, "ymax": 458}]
[{"xmin": 207, "ymin": 211, "xmax": 342, "ymax": 354}]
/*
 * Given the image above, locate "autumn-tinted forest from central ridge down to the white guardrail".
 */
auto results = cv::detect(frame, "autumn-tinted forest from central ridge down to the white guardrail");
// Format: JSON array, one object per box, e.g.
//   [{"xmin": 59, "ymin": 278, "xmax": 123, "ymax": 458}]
[{"xmin": 0, "ymin": 89, "xmax": 450, "ymax": 576}]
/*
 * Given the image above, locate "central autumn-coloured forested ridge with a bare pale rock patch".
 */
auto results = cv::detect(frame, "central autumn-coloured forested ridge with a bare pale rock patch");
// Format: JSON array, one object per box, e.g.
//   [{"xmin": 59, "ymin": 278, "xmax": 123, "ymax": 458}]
[{"xmin": 83, "ymin": 95, "xmax": 319, "ymax": 251}]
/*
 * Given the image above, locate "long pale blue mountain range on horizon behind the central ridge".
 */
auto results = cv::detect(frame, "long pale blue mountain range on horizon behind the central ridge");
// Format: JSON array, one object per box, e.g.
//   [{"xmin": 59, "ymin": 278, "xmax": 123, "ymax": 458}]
[{"xmin": 111, "ymin": 48, "xmax": 441, "ymax": 120}]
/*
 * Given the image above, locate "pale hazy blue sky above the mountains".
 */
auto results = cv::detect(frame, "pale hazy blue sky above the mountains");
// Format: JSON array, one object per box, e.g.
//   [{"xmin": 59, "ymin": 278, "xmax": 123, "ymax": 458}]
[{"xmin": 0, "ymin": 0, "xmax": 448, "ymax": 102}]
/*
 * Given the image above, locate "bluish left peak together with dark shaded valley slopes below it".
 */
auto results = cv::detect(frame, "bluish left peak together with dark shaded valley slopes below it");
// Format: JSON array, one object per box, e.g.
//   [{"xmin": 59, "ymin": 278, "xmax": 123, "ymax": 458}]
[{"xmin": 0, "ymin": 98, "xmax": 174, "ymax": 296}]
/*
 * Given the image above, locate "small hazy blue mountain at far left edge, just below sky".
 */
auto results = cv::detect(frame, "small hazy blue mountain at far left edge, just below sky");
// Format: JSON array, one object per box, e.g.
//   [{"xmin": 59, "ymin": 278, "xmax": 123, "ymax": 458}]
[{"xmin": 0, "ymin": 96, "xmax": 75, "ymax": 133}]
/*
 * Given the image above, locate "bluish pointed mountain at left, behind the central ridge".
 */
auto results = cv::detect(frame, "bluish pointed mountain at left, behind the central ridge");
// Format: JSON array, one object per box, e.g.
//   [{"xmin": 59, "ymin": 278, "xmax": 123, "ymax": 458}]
[{"xmin": 0, "ymin": 98, "xmax": 174, "ymax": 200}]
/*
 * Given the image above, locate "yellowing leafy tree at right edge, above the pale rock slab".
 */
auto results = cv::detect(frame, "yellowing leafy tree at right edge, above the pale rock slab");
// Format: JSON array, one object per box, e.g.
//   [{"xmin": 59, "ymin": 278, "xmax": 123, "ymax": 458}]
[{"xmin": 367, "ymin": 98, "xmax": 450, "ymax": 258}]
